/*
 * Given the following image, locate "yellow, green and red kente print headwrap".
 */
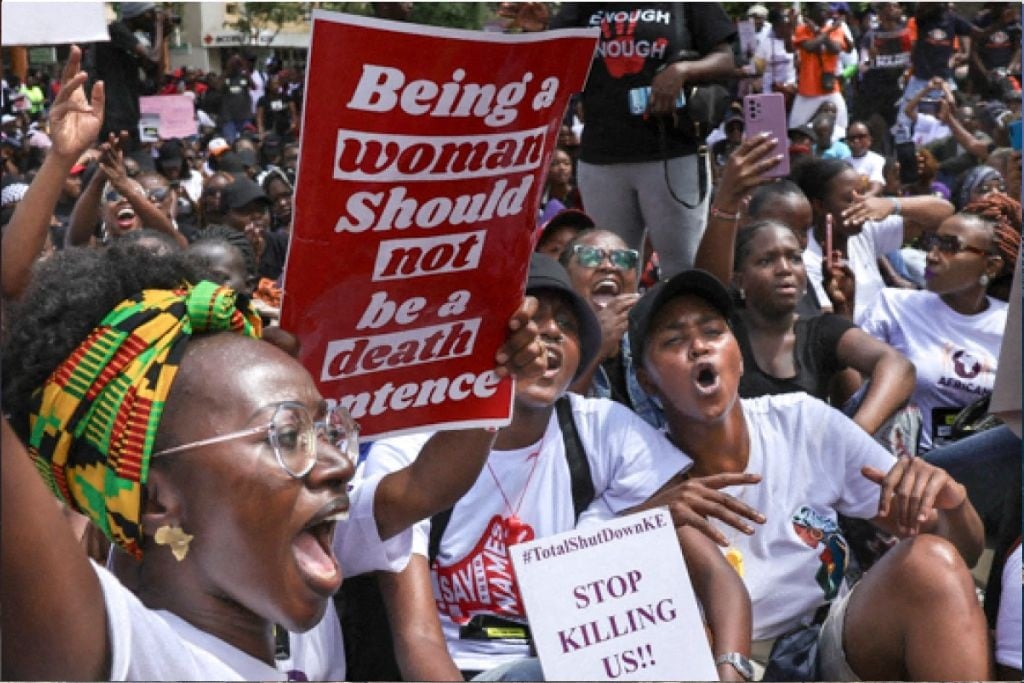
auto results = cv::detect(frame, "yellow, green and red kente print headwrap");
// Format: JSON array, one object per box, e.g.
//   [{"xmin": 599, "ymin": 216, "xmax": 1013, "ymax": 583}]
[{"xmin": 29, "ymin": 282, "xmax": 262, "ymax": 559}]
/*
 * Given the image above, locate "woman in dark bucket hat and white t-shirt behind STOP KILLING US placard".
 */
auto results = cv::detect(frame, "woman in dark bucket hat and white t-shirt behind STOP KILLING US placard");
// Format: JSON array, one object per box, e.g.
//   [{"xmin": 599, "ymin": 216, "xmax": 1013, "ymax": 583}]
[{"xmin": 366, "ymin": 254, "xmax": 750, "ymax": 680}]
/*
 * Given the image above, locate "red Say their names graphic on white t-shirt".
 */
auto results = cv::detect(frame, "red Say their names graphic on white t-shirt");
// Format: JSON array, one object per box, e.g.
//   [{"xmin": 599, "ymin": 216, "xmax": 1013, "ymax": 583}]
[{"xmin": 432, "ymin": 515, "xmax": 535, "ymax": 625}]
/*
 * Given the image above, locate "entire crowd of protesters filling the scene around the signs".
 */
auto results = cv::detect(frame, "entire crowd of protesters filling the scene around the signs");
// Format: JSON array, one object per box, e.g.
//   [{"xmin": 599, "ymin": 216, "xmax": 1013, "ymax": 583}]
[{"xmin": 0, "ymin": 2, "xmax": 1022, "ymax": 680}]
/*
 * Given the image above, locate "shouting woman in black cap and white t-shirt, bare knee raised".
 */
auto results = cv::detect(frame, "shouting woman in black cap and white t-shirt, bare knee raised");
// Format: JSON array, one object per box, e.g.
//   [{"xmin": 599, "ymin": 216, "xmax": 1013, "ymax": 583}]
[{"xmin": 630, "ymin": 270, "xmax": 992, "ymax": 681}]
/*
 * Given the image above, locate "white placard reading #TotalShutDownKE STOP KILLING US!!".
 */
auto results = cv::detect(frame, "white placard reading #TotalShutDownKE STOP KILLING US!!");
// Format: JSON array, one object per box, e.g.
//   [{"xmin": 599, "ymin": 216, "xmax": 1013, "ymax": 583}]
[{"xmin": 509, "ymin": 508, "xmax": 718, "ymax": 681}]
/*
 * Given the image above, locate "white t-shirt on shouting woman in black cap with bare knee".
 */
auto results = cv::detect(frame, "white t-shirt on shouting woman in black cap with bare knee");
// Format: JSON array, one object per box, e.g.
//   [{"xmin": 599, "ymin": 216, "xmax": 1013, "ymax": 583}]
[{"xmin": 716, "ymin": 393, "xmax": 895, "ymax": 640}]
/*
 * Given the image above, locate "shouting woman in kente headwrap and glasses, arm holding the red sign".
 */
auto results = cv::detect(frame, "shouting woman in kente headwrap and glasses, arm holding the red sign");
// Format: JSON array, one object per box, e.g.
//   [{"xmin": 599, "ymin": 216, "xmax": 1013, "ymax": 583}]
[{"xmin": 0, "ymin": 239, "xmax": 543, "ymax": 680}]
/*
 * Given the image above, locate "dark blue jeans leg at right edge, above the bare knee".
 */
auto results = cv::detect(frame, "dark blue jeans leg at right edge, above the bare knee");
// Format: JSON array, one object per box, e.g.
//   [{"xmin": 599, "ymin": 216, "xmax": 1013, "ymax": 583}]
[{"xmin": 925, "ymin": 425, "xmax": 1021, "ymax": 530}]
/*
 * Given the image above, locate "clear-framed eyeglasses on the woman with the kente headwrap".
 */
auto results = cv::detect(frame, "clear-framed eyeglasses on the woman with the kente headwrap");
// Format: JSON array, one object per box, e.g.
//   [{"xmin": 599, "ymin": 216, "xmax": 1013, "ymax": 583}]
[{"xmin": 153, "ymin": 401, "xmax": 359, "ymax": 479}]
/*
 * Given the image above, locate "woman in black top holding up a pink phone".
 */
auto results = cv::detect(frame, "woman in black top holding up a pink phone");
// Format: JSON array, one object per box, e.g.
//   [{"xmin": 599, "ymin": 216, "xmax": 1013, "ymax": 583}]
[{"xmin": 696, "ymin": 137, "xmax": 913, "ymax": 434}]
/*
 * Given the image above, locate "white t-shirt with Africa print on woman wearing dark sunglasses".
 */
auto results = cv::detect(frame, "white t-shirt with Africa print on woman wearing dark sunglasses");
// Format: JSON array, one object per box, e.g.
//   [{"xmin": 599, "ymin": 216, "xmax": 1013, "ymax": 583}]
[{"xmin": 861, "ymin": 289, "xmax": 1007, "ymax": 451}]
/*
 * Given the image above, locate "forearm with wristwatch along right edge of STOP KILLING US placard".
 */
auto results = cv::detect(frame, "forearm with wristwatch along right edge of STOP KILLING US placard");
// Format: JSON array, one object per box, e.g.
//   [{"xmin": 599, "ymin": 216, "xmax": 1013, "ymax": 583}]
[{"xmin": 677, "ymin": 527, "xmax": 753, "ymax": 681}]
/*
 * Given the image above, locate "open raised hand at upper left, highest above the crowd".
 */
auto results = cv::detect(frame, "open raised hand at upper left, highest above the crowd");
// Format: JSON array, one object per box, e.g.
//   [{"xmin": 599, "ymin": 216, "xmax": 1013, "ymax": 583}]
[{"xmin": 50, "ymin": 45, "xmax": 105, "ymax": 164}]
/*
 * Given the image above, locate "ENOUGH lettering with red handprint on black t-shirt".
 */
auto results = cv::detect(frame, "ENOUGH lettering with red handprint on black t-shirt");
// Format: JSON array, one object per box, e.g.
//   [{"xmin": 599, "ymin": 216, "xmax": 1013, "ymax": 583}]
[{"xmin": 590, "ymin": 9, "xmax": 672, "ymax": 78}]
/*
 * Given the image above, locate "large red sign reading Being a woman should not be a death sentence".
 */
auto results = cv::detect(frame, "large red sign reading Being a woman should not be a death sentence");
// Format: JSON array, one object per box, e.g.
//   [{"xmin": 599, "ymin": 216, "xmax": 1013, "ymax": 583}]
[{"xmin": 282, "ymin": 10, "xmax": 597, "ymax": 438}]
